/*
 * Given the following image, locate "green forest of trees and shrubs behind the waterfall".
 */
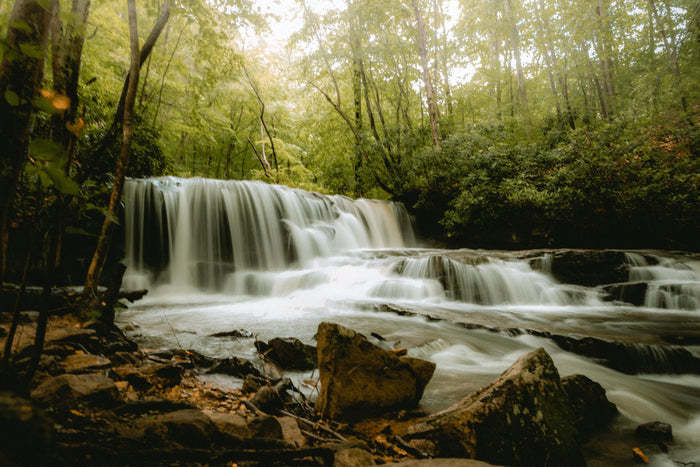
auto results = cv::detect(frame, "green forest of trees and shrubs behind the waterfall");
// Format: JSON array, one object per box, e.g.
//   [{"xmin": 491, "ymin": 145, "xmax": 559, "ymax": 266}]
[{"xmin": 0, "ymin": 0, "xmax": 700, "ymax": 286}]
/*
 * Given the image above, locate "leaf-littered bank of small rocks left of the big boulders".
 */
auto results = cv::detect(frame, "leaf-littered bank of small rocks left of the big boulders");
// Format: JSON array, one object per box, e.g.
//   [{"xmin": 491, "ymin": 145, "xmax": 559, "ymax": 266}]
[{"xmin": 0, "ymin": 312, "xmax": 688, "ymax": 466}]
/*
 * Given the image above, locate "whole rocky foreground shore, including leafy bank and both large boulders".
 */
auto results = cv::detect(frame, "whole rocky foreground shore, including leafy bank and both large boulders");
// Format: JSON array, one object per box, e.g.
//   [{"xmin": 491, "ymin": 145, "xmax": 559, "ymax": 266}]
[{"xmin": 0, "ymin": 312, "xmax": 672, "ymax": 466}]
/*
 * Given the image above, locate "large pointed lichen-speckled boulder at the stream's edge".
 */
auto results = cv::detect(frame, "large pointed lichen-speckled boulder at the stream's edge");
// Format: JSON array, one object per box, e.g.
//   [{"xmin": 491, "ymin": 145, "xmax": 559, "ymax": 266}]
[{"xmin": 406, "ymin": 348, "xmax": 585, "ymax": 466}]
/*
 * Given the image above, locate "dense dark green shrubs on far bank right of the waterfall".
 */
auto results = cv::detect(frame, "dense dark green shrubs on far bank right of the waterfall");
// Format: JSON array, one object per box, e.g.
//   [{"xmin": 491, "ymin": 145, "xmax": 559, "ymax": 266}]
[{"xmin": 404, "ymin": 110, "xmax": 700, "ymax": 249}]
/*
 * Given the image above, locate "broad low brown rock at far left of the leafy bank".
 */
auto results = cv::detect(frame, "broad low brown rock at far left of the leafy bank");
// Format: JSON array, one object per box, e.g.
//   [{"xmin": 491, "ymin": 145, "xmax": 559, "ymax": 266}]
[{"xmin": 31, "ymin": 374, "xmax": 123, "ymax": 408}]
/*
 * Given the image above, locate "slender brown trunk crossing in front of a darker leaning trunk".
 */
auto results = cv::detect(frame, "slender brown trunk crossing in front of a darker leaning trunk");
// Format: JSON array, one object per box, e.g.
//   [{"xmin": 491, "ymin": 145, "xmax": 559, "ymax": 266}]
[{"xmin": 83, "ymin": 0, "xmax": 142, "ymax": 318}]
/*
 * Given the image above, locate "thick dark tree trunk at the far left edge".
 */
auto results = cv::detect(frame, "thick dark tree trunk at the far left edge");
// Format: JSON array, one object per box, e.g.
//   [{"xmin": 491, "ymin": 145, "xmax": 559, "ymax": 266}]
[{"xmin": 0, "ymin": 0, "xmax": 50, "ymax": 283}]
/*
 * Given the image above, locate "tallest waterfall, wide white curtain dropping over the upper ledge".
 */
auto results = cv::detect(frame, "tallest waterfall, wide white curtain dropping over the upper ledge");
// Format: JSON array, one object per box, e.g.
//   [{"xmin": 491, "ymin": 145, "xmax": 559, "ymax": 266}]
[{"xmin": 124, "ymin": 177, "xmax": 413, "ymax": 290}]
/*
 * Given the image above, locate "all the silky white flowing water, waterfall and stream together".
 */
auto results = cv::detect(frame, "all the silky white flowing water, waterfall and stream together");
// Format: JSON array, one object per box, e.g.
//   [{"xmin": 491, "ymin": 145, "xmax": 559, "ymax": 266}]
[{"xmin": 118, "ymin": 178, "xmax": 700, "ymax": 465}]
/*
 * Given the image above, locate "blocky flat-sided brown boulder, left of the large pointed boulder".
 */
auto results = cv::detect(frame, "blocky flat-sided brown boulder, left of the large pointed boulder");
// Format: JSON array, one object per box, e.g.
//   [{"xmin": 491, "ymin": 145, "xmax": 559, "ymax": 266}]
[{"xmin": 316, "ymin": 322, "xmax": 435, "ymax": 418}]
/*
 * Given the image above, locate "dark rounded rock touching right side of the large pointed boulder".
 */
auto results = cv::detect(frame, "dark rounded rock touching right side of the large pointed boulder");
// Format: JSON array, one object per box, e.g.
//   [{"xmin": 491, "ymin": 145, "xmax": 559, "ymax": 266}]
[{"xmin": 561, "ymin": 375, "xmax": 618, "ymax": 434}]
